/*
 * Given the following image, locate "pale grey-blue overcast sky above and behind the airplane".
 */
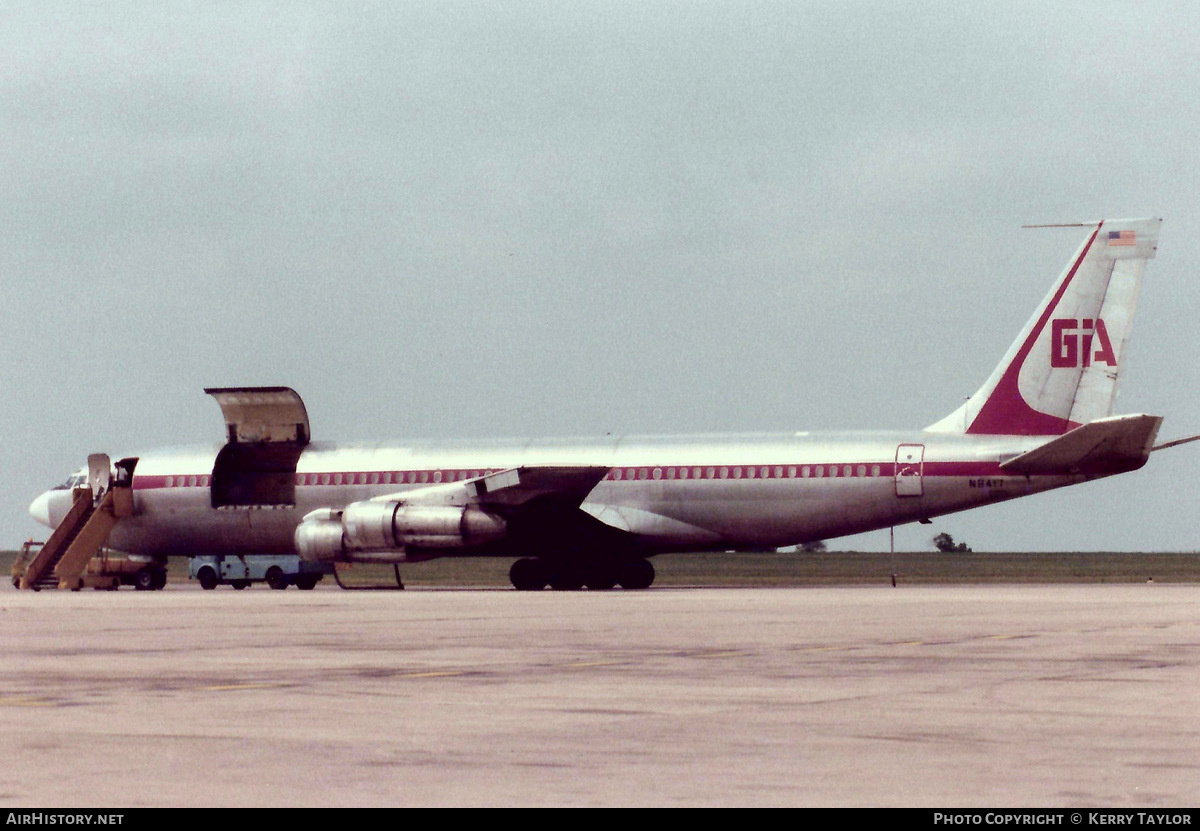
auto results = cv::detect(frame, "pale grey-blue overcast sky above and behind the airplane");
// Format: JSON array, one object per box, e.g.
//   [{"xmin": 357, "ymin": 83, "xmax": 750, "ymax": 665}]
[{"xmin": 0, "ymin": 0, "xmax": 1200, "ymax": 550}]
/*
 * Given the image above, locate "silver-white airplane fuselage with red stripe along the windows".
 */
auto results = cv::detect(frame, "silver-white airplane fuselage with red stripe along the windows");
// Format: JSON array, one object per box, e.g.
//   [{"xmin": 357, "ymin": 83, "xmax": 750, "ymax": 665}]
[{"xmin": 60, "ymin": 431, "xmax": 1094, "ymax": 556}]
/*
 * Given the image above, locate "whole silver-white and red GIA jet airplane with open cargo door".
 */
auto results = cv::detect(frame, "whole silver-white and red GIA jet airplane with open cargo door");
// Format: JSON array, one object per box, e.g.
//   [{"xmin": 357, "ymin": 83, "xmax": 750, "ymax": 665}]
[{"xmin": 30, "ymin": 217, "xmax": 1188, "ymax": 591}]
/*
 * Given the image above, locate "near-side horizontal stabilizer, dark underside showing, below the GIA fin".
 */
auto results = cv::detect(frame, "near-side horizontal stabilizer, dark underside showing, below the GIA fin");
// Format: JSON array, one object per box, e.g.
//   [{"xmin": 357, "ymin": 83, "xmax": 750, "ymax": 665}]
[{"xmin": 1000, "ymin": 416, "xmax": 1163, "ymax": 474}]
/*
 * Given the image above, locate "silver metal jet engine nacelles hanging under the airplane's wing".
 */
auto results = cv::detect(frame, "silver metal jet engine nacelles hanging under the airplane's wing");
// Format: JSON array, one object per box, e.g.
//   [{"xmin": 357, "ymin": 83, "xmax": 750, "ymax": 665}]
[{"xmin": 294, "ymin": 502, "xmax": 506, "ymax": 562}]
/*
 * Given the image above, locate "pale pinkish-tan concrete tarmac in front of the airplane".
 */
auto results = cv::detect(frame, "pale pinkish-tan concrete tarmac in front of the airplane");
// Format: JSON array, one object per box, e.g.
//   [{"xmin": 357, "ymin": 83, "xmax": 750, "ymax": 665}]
[{"xmin": 0, "ymin": 584, "xmax": 1200, "ymax": 808}]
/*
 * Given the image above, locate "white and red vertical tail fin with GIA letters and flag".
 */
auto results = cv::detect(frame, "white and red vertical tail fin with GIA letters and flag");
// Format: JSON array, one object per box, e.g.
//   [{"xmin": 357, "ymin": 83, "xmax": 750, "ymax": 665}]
[{"xmin": 926, "ymin": 217, "xmax": 1162, "ymax": 436}]
